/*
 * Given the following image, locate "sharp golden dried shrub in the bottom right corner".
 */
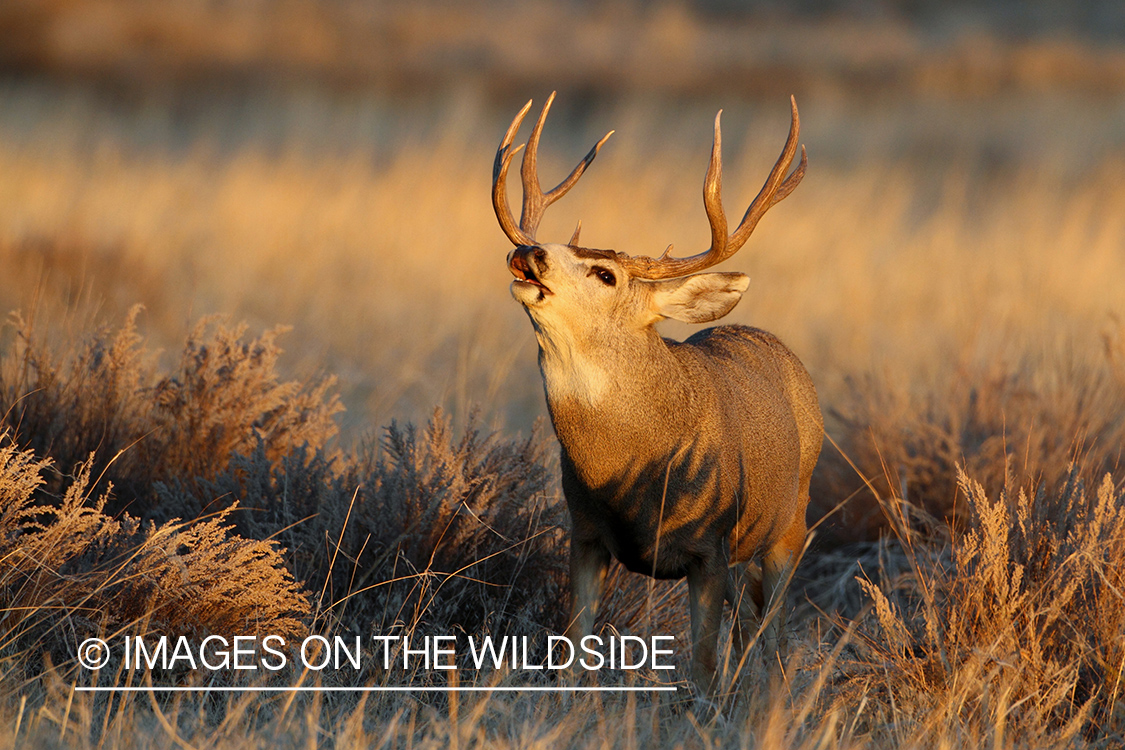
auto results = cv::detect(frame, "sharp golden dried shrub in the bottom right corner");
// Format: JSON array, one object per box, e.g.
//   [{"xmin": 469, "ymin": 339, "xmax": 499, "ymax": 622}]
[{"xmin": 837, "ymin": 468, "xmax": 1125, "ymax": 747}]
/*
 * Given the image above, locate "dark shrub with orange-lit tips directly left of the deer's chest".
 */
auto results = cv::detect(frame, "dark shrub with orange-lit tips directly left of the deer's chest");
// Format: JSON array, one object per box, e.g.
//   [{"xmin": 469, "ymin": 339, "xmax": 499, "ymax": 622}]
[{"xmin": 356, "ymin": 413, "xmax": 566, "ymax": 632}]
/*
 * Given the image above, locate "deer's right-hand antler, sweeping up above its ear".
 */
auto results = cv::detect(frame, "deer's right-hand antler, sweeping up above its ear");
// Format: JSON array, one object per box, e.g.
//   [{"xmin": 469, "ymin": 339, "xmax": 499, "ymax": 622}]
[{"xmin": 618, "ymin": 97, "xmax": 808, "ymax": 279}]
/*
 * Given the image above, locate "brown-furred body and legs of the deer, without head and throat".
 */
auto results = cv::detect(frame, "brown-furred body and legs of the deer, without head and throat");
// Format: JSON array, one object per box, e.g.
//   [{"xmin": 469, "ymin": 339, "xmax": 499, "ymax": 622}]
[{"xmin": 548, "ymin": 312, "xmax": 824, "ymax": 689}]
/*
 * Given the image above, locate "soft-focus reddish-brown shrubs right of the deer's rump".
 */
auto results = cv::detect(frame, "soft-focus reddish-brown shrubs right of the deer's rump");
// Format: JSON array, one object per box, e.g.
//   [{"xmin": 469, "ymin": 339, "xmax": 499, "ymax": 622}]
[{"xmin": 812, "ymin": 344, "xmax": 1125, "ymax": 540}]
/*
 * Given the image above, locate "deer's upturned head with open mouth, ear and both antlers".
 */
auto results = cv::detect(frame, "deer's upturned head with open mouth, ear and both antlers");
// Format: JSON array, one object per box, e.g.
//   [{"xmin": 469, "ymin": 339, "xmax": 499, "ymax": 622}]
[{"xmin": 493, "ymin": 93, "xmax": 808, "ymax": 339}]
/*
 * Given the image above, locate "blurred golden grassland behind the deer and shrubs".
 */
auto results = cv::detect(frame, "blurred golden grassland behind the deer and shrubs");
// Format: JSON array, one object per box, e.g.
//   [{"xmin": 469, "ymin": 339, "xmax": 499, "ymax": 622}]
[{"xmin": 0, "ymin": 0, "xmax": 1125, "ymax": 463}]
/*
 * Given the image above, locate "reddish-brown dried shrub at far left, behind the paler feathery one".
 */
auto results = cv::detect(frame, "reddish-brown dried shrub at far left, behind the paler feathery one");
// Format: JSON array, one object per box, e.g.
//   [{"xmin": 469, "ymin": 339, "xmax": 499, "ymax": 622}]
[{"xmin": 0, "ymin": 307, "xmax": 342, "ymax": 519}]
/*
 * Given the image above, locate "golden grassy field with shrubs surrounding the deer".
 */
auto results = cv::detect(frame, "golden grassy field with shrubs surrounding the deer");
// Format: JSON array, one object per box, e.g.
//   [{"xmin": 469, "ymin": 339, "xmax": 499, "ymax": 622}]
[{"xmin": 0, "ymin": 2, "xmax": 1125, "ymax": 748}]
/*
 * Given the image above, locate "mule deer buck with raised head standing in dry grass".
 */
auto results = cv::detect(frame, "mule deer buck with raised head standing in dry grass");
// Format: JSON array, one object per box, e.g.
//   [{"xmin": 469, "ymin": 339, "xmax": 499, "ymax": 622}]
[{"xmin": 493, "ymin": 93, "xmax": 824, "ymax": 694}]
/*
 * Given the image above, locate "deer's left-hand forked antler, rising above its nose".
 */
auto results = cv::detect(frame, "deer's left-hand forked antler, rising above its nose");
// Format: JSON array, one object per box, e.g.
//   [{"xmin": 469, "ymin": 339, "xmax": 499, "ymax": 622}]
[{"xmin": 493, "ymin": 91, "xmax": 613, "ymax": 245}]
